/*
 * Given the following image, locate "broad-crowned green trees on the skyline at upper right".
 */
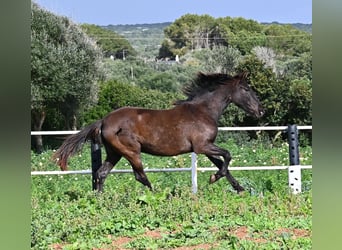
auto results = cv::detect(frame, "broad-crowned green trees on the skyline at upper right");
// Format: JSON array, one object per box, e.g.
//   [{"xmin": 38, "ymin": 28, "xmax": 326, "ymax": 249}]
[{"xmin": 160, "ymin": 14, "xmax": 311, "ymax": 57}]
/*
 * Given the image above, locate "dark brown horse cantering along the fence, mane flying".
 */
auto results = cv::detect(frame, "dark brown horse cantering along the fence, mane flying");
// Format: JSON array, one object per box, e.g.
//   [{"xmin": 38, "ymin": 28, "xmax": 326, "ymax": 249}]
[{"xmin": 53, "ymin": 73, "xmax": 264, "ymax": 192}]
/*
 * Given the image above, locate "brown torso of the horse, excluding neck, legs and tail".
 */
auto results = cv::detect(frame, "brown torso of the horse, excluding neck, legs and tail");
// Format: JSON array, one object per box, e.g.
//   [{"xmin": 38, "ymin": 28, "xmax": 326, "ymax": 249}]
[{"xmin": 99, "ymin": 106, "xmax": 215, "ymax": 156}]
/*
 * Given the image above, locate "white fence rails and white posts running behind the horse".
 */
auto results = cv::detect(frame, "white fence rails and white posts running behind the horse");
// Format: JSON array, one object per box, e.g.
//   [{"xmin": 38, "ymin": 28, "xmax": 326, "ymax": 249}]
[{"xmin": 31, "ymin": 125, "xmax": 312, "ymax": 194}]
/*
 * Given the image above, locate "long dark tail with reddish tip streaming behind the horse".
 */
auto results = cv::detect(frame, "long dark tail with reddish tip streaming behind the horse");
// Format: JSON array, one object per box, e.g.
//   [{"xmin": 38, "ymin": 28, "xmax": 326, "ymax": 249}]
[{"xmin": 52, "ymin": 120, "xmax": 102, "ymax": 171}]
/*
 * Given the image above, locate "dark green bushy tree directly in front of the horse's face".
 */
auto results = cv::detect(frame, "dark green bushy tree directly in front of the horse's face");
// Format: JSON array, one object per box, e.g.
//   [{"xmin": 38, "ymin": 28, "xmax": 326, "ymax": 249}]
[{"xmin": 238, "ymin": 55, "xmax": 312, "ymax": 129}]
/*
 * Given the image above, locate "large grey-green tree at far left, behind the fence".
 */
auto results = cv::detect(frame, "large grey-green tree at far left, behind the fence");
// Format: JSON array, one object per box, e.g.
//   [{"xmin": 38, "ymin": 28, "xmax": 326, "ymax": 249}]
[{"xmin": 31, "ymin": 3, "xmax": 102, "ymax": 151}]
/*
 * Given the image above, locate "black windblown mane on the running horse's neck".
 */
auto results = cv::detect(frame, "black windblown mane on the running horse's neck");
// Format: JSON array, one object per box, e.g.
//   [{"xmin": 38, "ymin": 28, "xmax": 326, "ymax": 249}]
[{"xmin": 174, "ymin": 72, "xmax": 233, "ymax": 105}]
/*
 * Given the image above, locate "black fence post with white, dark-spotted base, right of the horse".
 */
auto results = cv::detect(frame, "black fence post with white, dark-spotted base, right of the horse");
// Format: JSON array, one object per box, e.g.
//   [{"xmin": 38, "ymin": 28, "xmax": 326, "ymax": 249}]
[{"xmin": 287, "ymin": 125, "xmax": 302, "ymax": 194}]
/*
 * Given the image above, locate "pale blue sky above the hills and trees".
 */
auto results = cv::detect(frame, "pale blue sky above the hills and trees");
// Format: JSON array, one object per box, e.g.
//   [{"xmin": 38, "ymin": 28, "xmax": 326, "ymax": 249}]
[{"xmin": 33, "ymin": 0, "xmax": 312, "ymax": 25}]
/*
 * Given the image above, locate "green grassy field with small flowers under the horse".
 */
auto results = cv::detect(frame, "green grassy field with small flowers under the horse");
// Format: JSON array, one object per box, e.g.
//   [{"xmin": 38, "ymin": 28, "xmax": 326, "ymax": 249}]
[{"xmin": 31, "ymin": 142, "xmax": 312, "ymax": 249}]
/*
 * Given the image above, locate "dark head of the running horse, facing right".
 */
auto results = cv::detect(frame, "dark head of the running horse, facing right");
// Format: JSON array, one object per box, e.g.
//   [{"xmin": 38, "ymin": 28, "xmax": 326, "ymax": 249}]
[{"xmin": 230, "ymin": 73, "xmax": 265, "ymax": 118}]
